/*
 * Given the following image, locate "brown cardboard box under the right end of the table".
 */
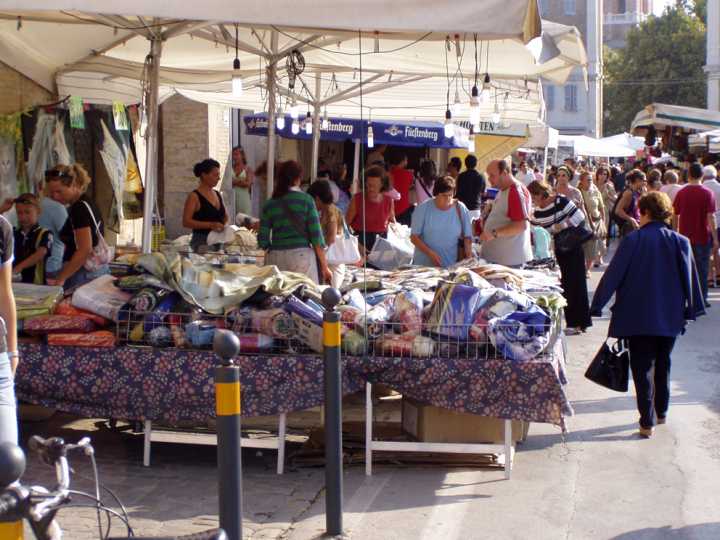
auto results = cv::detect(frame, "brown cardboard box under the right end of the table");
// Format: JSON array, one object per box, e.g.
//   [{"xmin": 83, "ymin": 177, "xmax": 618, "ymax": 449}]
[{"xmin": 402, "ymin": 398, "xmax": 530, "ymax": 444}]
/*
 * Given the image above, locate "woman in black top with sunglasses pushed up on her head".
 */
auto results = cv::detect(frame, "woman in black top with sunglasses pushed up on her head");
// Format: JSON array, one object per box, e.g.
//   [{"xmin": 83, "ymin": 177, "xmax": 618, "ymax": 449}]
[{"xmin": 45, "ymin": 163, "xmax": 110, "ymax": 289}]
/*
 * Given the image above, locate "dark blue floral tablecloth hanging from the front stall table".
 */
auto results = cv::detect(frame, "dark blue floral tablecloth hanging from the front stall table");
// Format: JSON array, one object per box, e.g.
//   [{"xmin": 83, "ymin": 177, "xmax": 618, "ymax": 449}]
[{"xmin": 15, "ymin": 344, "xmax": 572, "ymax": 426}]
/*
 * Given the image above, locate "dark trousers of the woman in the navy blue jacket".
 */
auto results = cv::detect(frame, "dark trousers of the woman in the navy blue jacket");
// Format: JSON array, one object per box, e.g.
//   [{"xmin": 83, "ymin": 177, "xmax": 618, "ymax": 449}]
[{"xmin": 628, "ymin": 336, "xmax": 675, "ymax": 428}]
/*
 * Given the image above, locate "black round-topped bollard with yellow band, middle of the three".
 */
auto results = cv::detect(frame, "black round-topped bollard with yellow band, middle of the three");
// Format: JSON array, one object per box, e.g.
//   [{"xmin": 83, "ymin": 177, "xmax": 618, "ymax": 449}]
[{"xmin": 213, "ymin": 330, "xmax": 242, "ymax": 540}]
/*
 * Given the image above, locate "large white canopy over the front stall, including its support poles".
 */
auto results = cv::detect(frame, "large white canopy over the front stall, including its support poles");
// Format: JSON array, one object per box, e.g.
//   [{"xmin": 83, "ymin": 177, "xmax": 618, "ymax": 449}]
[{"xmin": 0, "ymin": 0, "xmax": 585, "ymax": 251}]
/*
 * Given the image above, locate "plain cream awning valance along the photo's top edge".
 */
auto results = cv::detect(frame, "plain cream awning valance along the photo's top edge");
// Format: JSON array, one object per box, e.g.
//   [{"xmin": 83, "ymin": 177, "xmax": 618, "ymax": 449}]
[{"xmin": 0, "ymin": 0, "xmax": 540, "ymax": 39}]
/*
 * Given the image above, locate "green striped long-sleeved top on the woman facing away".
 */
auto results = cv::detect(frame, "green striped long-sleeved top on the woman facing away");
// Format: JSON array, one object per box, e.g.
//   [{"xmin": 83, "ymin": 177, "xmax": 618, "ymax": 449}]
[{"xmin": 258, "ymin": 190, "xmax": 325, "ymax": 250}]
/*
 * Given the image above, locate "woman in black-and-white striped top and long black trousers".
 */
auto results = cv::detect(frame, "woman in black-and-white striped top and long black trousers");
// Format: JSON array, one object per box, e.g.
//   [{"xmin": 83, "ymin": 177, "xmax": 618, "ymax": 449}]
[{"xmin": 528, "ymin": 181, "xmax": 592, "ymax": 334}]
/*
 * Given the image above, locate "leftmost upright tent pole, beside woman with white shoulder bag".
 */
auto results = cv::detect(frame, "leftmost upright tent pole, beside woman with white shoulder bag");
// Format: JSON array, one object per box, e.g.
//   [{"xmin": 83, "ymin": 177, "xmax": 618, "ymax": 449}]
[{"xmin": 142, "ymin": 36, "xmax": 162, "ymax": 253}]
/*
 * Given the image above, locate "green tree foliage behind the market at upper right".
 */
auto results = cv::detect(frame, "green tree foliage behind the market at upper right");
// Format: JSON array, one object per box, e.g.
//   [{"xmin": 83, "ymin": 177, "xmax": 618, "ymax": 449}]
[{"xmin": 603, "ymin": 4, "xmax": 707, "ymax": 134}]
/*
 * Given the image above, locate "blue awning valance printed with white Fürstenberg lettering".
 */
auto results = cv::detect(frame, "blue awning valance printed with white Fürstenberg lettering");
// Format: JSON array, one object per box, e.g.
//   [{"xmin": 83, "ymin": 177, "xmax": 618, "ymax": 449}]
[{"xmin": 243, "ymin": 113, "xmax": 469, "ymax": 148}]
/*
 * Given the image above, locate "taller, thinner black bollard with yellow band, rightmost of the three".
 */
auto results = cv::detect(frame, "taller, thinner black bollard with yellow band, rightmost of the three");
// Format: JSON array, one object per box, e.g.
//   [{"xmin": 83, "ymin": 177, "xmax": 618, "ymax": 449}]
[{"xmin": 322, "ymin": 288, "xmax": 343, "ymax": 536}]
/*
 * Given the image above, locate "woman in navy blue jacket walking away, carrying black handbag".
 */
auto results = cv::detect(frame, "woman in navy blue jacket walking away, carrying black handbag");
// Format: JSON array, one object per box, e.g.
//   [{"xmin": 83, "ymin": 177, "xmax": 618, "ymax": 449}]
[{"xmin": 590, "ymin": 192, "xmax": 705, "ymax": 438}]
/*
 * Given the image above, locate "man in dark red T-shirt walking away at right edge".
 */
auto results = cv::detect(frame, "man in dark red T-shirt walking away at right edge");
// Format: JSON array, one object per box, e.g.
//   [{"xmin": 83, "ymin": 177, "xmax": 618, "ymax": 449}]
[{"xmin": 673, "ymin": 163, "xmax": 718, "ymax": 307}]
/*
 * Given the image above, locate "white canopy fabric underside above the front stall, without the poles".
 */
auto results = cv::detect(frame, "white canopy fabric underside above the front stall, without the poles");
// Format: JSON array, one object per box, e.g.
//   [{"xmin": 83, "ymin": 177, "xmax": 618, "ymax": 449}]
[{"xmin": 0, "ymin": 10, "xmax": 586, "ymax": 123}]
